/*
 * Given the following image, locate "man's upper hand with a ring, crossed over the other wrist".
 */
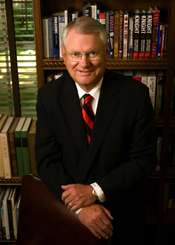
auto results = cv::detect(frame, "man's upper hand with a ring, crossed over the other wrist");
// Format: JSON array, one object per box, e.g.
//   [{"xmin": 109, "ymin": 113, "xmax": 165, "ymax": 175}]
[{"xmin": 61, "ymin": 184, "xmax": 96, "ymax": 211}]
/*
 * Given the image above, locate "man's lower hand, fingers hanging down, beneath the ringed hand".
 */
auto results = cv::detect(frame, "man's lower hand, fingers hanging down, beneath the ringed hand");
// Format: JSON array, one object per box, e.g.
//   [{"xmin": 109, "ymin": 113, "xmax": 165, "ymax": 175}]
[{"xmin": 78, "ymin": 204, "xmax": 113, "ymax": 239}]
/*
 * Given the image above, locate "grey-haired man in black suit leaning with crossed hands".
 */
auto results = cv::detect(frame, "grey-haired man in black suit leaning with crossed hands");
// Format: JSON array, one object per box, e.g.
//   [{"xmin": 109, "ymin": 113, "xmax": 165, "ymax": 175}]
[{"xmin": 36, "ymin": 17, "xmax": 155, "ymax": 244}]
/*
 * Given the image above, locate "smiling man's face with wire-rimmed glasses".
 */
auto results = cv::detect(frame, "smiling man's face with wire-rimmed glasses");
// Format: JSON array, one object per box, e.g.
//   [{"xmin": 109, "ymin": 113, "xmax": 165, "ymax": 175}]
[{"xmin": 62, "ymin": 29, "xmax": 106, "ymax": 91}]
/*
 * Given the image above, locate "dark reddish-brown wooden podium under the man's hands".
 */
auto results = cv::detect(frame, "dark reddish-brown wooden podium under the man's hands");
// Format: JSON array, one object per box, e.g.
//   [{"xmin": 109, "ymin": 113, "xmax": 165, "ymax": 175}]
[{"xmin": 16, "ymin": 175, "xmax": 107, "ymax": 245}]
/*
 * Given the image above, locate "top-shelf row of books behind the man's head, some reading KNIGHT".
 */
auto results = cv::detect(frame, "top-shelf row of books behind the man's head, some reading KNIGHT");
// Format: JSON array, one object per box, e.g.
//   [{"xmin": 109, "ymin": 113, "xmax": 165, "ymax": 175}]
[{"xmin": 42, "ymin": 5, "xmax": 168, "ymax": 59}]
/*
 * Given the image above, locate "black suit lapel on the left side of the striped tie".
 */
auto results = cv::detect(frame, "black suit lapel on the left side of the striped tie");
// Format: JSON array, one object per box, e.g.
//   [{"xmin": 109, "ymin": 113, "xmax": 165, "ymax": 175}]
[{"xmin": 60, "ymin": 73, "xmax": 86, "ymax": 150}]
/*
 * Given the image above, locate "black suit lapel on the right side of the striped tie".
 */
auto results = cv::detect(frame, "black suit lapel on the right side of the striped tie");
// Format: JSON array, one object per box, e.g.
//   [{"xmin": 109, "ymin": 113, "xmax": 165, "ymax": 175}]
[{"xmin": 79, "ymin": 72, "xmax": 120, "ymax": 182}]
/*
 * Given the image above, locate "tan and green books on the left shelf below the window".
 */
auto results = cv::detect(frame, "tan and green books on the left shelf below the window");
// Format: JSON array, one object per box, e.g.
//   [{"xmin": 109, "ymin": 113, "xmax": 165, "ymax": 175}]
[{"xmin": 0, "ymin": 114, "xmax": 36, "ymax": 178}]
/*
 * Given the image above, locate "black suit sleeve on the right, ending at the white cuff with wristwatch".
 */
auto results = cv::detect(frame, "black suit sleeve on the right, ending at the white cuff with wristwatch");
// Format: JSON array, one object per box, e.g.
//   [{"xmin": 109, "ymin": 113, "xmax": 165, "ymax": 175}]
[{"xmin": 97, "ymin": 84, "xmax": 156, "ymax": 200}]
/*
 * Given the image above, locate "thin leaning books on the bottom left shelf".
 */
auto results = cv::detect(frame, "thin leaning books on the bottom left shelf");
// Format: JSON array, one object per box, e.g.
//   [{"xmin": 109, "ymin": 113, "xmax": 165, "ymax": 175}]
[{"xmin": 0, "ymin": 186, "xmax": 21, "ymax": 240}]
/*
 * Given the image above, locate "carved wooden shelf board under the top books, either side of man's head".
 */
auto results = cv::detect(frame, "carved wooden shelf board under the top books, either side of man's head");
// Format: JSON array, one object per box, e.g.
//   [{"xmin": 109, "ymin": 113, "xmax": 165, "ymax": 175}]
[{"xmin": 42, "ymin": 58, "xmax": 168, "ymax": 70}]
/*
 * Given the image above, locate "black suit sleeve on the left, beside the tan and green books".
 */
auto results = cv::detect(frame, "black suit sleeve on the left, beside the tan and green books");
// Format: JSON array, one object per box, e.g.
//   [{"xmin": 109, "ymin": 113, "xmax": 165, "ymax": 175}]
[{"xmin": 36, "ymin": 89, "xmax": 73, "ymax": 199}]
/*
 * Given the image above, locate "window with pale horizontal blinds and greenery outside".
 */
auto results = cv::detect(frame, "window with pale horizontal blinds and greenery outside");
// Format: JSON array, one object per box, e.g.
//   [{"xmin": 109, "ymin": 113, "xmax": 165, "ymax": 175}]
[{"xmin": 0, "ymin": 0, "xmax": 37, "ymax": 116}]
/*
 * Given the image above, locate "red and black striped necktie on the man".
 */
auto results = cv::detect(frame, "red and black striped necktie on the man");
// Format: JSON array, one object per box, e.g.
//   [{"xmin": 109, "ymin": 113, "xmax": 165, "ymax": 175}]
[{"xmin": 82, "ymin": 94, "xmax": 95, "ymax": 144}]
